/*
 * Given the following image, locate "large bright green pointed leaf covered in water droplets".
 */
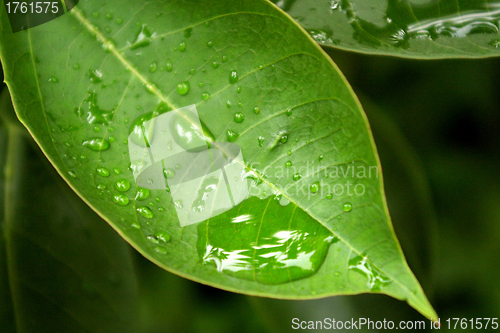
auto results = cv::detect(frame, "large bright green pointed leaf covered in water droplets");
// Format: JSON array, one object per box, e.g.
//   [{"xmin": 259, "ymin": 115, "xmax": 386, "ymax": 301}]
[{"xmin": 0, "ymin": 1, "xmax": 436, "ymax": 318}]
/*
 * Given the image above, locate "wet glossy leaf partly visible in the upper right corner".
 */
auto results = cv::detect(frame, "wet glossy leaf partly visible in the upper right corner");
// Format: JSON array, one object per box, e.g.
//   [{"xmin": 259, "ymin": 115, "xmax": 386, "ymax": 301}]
[{"xmin": 273, "ymin": 0, "xmax": 500, "ymax": 59}]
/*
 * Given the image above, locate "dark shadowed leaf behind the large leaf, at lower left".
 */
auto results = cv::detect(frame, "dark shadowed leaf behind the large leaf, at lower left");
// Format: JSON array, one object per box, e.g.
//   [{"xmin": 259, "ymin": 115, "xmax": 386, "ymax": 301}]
[{"xmin": 1, "ymin": 89, "xmax": 137, "ymax": 333}]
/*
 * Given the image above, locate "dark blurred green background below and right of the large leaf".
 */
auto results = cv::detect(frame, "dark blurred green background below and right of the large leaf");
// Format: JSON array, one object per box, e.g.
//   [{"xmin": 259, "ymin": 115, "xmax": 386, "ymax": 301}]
[{"xmin": 0, "ymin": 50, "xmax": 500, "ymax": 333}]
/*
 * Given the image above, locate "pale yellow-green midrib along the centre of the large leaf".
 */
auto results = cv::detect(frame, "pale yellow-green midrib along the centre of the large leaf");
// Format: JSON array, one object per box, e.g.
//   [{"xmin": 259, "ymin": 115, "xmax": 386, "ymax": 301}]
[{"xmin": 70, "ymin": 7, "xmax": 422, "ymax": 304}]
